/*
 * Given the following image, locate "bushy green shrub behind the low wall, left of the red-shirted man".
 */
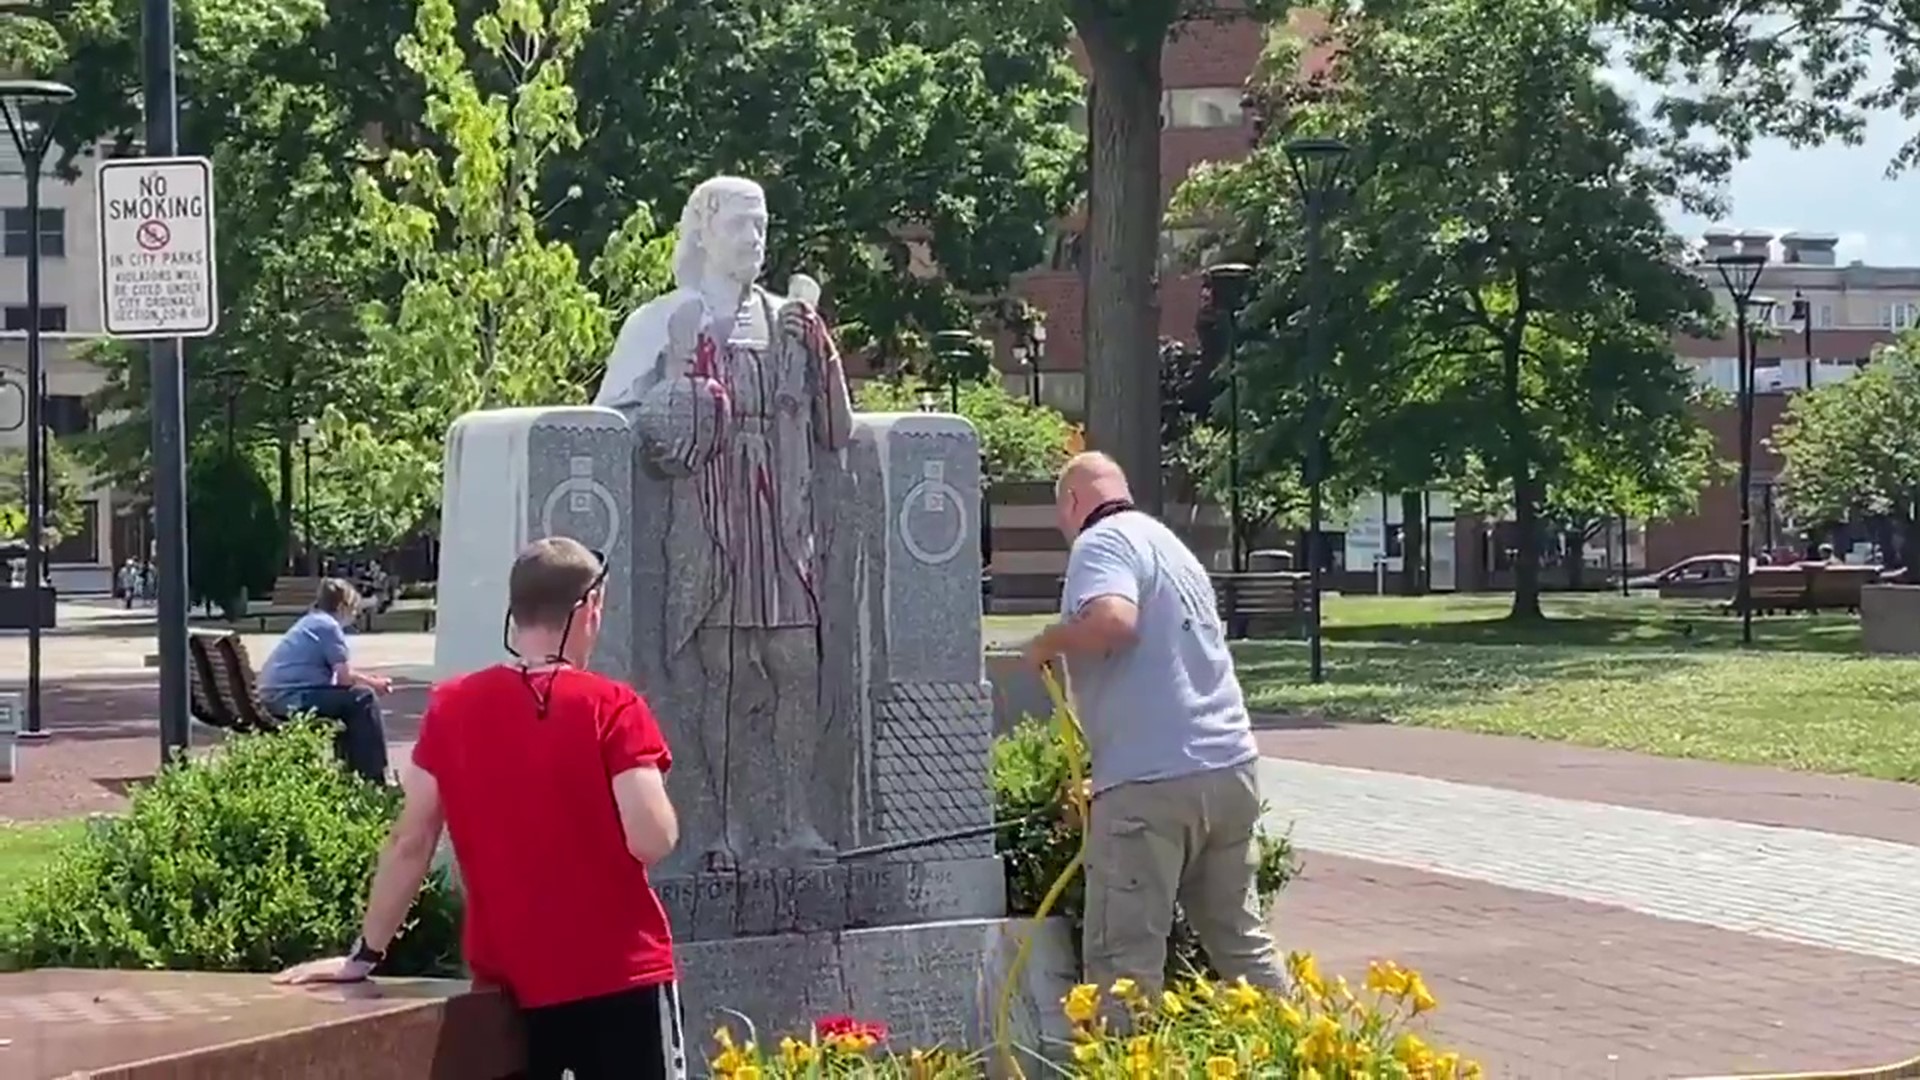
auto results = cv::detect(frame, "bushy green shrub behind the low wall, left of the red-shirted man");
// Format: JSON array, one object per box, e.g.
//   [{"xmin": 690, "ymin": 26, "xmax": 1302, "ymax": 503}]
[{"xmin": 0, "ymin": 724, "xmax": 459, "ymax": 974}]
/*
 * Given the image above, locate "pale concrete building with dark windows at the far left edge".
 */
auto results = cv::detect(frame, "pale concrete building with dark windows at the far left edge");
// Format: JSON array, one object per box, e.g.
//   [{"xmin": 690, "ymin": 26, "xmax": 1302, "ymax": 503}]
[{"xmin": 0, "ymin": 136, "xmax": 117, "ymax": 592}]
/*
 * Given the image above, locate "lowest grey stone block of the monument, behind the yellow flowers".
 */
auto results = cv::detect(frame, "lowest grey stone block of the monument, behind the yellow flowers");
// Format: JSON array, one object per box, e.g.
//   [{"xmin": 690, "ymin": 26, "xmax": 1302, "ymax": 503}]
[{"xmin": 674, "ymin": 919, "xmax": 1079, "ymax": 1061}]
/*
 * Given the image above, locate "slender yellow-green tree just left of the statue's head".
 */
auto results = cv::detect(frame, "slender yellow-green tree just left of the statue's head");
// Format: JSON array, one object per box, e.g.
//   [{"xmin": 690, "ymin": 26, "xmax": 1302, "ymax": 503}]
[{"xmin": 337, "ymin": 0, "xmax": 670, "ymax": 532}]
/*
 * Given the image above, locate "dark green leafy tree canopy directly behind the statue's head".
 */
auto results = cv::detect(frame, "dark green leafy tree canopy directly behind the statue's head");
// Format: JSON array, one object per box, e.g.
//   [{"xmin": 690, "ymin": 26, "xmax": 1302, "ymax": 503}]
[{"xmin": 547, "ymin": 0, "xmax": 1081, "ymax": 369}]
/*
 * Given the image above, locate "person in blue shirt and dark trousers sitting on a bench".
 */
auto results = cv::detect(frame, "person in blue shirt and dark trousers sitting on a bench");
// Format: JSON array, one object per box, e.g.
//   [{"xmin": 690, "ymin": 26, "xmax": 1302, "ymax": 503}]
[{"xmin": 259, "ymin": 578, "xmax": 394, "ymax": 784}]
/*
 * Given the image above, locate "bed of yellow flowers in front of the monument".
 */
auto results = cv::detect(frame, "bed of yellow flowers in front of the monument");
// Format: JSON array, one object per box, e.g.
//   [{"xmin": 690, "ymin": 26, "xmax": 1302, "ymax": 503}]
[{"xmin": 710, "ymin": 953, "xmax": 1480, "ymax": 1080}]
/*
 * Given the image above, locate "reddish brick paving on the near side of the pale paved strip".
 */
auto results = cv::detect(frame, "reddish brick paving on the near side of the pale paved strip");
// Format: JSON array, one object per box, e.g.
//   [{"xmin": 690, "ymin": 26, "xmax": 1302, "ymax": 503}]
[{"xmin": 1275, "ymin": 851, "xmax": 1920, "ymax": 1080}]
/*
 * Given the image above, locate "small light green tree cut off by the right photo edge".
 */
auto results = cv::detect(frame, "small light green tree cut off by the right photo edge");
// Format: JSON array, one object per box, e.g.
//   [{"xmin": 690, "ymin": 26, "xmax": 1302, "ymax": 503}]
[{"xmin": 1772, "ymin": 334, "xmax": 1920, "ymax": 567}]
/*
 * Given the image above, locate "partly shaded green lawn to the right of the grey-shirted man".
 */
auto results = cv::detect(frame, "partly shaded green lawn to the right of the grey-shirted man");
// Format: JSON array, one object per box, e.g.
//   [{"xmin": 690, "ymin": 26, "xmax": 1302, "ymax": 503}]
[{"xmin": 1240, "ymin": 596, "xmax": 1920, "ymax": 780}]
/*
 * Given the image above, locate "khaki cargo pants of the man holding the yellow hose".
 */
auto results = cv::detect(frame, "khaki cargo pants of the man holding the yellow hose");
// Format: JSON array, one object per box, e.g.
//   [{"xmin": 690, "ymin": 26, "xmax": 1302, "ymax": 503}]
[{"xmin": 1081, "ymin": 761, "xmax": 1281, "ymax": 994}]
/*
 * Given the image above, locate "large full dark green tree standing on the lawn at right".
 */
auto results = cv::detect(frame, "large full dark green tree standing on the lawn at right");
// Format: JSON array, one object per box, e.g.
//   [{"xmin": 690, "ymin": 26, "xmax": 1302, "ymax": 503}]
[{"xmin": 1183, "ymin": 0, "xmax": 1713, "ymax": 619}]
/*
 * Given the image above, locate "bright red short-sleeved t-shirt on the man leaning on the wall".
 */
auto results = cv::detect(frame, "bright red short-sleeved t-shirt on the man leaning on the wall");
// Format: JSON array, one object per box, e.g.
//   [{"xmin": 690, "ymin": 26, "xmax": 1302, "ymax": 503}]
[{"xmin": 413, "ymin": 665, "xmax": 674, "ymax": 1009}]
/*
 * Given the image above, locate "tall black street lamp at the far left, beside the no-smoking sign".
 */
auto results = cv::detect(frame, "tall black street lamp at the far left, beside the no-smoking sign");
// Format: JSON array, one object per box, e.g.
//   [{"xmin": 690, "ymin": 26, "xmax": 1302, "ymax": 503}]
[{"xmin": 0, "ymin": 79, "xmax": 73, "ymax": 740}]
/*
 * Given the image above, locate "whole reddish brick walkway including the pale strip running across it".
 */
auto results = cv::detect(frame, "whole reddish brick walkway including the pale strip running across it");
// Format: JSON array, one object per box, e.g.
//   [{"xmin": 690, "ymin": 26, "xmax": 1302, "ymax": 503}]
[{"xmin": 1260, "ymin": 724, "xmax": 1920, "ymax": 1080}]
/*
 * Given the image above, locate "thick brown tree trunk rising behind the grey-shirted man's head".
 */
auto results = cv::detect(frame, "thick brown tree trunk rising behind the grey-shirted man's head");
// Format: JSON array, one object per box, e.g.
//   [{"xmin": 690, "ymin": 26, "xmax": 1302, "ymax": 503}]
[{"xmin": 1071, "ymin": 2, "xmax": 1171, "ymax": 513}]
